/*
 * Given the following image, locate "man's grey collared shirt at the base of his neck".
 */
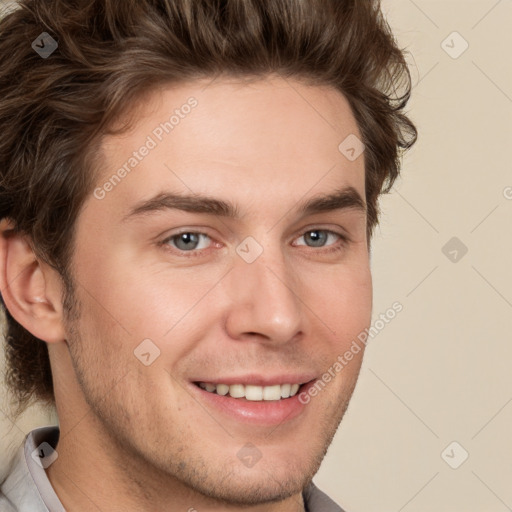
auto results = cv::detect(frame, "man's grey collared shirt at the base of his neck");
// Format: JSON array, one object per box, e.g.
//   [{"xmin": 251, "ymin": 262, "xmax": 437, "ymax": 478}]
[{"xmin": 0, "ymin": 427, "xmax": 343, "ymax": 512}]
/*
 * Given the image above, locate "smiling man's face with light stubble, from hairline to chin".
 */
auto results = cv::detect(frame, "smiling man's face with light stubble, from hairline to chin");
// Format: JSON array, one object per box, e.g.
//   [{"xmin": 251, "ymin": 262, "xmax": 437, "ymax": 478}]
[{"xmin": 56, "ymin": 75, "xmax": 372, "ymax": 504}]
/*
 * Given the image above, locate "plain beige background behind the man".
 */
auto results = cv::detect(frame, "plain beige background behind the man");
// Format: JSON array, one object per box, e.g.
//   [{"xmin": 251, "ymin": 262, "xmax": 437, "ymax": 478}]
[{"xmin": 0, "ymin": 0, "xmax": 512, "ymax": 512}]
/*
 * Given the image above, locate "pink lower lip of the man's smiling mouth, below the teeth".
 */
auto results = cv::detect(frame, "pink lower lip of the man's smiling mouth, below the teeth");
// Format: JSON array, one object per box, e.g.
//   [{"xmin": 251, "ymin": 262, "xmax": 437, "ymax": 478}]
[{"xmin": 190, "ymin": 379, "xmax": 316, "ymax": 426}]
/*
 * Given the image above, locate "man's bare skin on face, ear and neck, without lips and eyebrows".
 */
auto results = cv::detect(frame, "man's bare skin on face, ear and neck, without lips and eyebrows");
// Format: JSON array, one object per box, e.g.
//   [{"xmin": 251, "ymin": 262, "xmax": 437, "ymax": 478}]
[{"xmin": 1, "ymin": 77, "xmax": 372, "ymax": 512}]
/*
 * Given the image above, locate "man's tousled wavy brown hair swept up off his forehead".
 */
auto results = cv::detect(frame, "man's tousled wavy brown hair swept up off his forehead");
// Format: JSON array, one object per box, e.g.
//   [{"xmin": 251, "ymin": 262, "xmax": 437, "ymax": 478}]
[{"xmin": 0, "ymin": 0, "xmax": 417, "ymax": 411}]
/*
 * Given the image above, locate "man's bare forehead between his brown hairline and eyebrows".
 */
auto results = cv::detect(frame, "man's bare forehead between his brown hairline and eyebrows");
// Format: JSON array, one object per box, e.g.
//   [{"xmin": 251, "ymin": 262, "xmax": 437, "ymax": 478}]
[{"xmin": 90, "ymin": 78, "xmax": 364, "ymax": 218}]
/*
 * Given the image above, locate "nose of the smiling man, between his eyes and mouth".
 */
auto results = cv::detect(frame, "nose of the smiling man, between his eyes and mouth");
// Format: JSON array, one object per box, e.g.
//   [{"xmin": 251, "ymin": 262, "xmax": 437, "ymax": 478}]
[{"xmin": 226, "ymin": 243, "xmax": 305, "ymax": 344}]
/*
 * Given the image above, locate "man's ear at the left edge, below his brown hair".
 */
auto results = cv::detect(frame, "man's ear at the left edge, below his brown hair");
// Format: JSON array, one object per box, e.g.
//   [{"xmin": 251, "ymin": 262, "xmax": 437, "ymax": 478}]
[{"xmin": 0, "ymin": 219, "xmax": 66, "ymax": 343}]
